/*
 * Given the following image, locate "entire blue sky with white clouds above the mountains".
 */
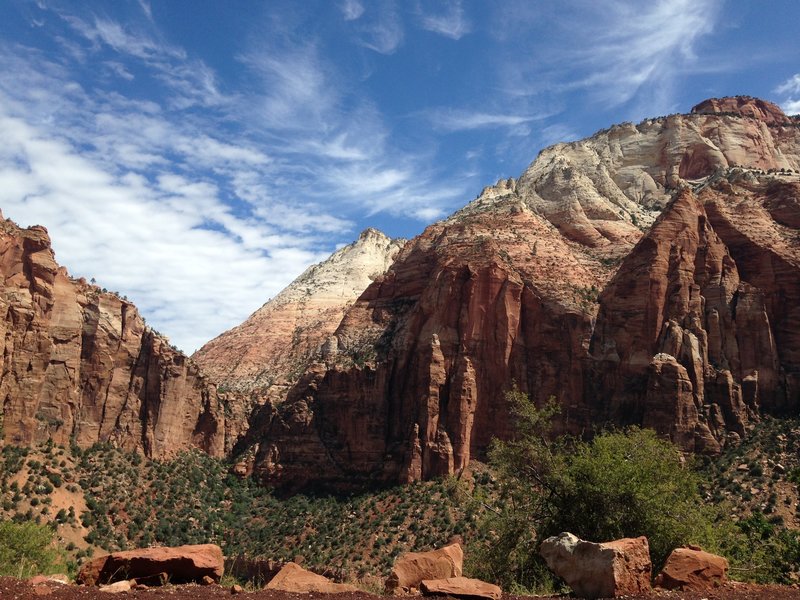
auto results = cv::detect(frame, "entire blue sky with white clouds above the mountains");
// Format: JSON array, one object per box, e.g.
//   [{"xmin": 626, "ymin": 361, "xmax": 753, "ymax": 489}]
[{"xmin": 0, "ymin": 0, "xmax": 800, "ymax": 352}]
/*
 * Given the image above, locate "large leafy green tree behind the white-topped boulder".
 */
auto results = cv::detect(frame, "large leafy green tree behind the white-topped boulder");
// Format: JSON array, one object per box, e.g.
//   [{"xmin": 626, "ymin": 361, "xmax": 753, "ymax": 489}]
[{"xmin": 472, "ymin": 389, "xmax": 712, "ymax": 589}]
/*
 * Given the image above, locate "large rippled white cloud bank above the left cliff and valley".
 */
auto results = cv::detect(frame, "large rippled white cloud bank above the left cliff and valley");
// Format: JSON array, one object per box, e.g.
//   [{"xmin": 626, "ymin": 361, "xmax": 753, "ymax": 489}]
[{"xmin": 0, "ymin": 3, "xmax": 464, "ymax": 352}]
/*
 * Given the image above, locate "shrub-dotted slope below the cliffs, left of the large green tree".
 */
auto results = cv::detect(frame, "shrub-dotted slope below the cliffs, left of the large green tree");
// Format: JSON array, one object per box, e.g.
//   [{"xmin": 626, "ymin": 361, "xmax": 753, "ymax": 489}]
[{"xmin": 0, "ymin": 444, "xmax": 492, "ymax": 580}]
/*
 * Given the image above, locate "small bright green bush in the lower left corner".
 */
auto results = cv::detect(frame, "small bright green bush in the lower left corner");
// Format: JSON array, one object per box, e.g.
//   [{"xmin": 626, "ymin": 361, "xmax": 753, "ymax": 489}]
[{"xmin": 0, "ymin": 521, "xmax": 66, "ymax": 577}]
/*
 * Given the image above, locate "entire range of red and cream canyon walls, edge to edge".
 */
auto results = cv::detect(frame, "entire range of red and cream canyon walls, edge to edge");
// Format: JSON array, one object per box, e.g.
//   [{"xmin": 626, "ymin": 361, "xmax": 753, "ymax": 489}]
[{"xmin": 0, "ymin": 97, "xmax": 800, "ymax": 490}]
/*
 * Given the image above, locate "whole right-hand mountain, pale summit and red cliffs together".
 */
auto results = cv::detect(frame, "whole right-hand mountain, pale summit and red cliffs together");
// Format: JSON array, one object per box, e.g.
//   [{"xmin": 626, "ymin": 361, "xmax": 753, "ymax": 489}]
[{"xmin": 239, "ymin": 98, "xmax": 800, "ymax": 486}]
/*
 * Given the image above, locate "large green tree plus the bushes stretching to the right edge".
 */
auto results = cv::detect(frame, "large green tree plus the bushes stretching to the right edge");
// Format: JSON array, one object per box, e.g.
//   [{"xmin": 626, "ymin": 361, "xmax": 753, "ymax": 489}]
[{"xmin": 462, "ymin": 391, "xmax": 800, "ymax": 590}]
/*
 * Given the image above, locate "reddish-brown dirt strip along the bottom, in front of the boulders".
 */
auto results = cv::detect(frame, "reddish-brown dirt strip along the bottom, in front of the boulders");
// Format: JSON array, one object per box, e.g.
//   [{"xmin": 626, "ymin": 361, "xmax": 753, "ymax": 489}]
[{"xmin": 0, "ymin": 577, "xmax": 800, "ymax": 600}]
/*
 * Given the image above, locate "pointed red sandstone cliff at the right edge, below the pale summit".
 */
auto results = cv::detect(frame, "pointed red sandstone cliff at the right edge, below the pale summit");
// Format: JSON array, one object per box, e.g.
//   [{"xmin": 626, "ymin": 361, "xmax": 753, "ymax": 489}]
[{"xmin": 588, "ymin": 173, "xmax": 800, "ymax": 452}]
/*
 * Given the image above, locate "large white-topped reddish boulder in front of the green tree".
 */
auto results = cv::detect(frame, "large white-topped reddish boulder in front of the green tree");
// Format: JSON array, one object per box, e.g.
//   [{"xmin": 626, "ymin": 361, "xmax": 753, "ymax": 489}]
[{"xmin": 539, "ymin": 533, "xmax": 653, "ymax": 598}]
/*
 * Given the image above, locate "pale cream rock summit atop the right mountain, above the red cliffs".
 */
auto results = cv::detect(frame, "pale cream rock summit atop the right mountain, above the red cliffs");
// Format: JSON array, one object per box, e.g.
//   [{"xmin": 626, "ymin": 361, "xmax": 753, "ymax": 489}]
[{"xmin": 517, "ymin": 98, "xmax": 800, "ymax": 250}]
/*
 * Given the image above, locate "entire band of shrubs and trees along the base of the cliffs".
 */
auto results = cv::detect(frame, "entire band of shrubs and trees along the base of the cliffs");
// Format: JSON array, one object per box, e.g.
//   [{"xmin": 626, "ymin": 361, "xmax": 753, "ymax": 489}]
[{"xmin": 0, "ymin": 408, "xmax": 800, "ymax": 591}]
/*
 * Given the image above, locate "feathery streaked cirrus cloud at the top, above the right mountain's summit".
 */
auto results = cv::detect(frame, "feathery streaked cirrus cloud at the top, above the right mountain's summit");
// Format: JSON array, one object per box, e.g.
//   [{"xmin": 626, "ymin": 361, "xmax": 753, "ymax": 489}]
[{"xmin": 492, "ymin": 0, "xmax": 724, "ymax": 116}]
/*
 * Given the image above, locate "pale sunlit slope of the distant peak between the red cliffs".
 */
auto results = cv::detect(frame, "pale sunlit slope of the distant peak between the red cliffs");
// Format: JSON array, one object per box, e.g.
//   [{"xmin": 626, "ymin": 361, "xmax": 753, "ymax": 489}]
[{"xmin": 192, "ymin": 229, "xmax": 405, "ymax": 400}]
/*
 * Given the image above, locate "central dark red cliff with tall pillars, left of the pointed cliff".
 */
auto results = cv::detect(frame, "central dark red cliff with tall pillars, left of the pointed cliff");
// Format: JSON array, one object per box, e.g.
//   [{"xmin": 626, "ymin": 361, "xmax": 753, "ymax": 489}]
[{"xmin": 250, "ymin": 199, "xmax": 610, "ymax": 486}]
